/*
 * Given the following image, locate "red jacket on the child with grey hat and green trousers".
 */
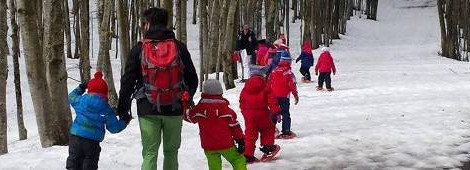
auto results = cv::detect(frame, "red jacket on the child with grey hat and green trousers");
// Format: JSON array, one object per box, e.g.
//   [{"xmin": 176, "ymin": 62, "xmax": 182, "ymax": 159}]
[{"xmin": 184, "ymin": 94, "xmax": 244, "ymax": 150}]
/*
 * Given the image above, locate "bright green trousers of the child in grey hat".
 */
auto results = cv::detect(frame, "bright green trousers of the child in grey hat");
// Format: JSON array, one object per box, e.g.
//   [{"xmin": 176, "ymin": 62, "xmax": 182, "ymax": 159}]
[{"xmin": 204, "ymin": 147, "xmax": 247, "ymax": 170}]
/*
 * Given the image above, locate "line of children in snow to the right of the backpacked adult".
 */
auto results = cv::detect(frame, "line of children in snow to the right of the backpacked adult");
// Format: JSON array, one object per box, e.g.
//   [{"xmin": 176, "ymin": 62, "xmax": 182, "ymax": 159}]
[{"xmin": 184, "ymin": 36, "xmax": 336, "ymax": 170}]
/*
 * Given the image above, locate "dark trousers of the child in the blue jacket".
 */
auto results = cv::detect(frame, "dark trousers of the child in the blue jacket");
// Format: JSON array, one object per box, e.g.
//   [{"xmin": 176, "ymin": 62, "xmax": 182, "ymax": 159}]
[{"xmin": 65, "ymin": 135, "xmax": 101, "ymax": 170}]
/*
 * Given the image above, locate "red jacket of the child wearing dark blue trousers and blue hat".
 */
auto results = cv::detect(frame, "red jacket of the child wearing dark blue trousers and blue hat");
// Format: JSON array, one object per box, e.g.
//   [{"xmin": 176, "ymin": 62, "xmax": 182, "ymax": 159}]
[{"xmin": 268, "ymin": 61, "xmax": 298, "ymax": 97}]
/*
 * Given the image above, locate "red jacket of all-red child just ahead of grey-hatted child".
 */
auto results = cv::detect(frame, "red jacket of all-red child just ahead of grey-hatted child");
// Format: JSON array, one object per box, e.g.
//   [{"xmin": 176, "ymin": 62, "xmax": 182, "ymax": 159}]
[{"xmin": 240, "ymin": 76, "xmax": 281, "ymax": 116}]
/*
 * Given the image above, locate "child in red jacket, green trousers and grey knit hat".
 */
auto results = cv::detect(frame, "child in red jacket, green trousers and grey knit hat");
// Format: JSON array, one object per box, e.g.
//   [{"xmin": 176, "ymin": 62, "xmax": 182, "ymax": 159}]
[{"xmin": 184, "ymin": 79, "xmax": 247, "ymax": 170}]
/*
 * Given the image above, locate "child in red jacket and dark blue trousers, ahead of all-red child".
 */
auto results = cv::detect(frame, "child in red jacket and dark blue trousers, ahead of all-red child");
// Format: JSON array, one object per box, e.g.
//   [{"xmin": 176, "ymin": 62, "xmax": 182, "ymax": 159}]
[{"xmin": 268, "ymin": 58, "xmax": 299, "ymax": 139}]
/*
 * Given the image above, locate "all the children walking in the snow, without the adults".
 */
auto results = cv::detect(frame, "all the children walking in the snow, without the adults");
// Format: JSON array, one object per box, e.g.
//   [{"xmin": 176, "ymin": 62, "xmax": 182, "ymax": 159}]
[{"xmin": 67, "ymin": 34, "xmax": 336, "ymax": 170}]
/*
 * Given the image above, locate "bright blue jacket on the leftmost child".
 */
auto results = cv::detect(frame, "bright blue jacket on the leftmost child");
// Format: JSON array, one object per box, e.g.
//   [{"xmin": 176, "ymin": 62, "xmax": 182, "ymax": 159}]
[{"xmin": 69, "ymin": 87, "xmax": 126, "ymax": 142}]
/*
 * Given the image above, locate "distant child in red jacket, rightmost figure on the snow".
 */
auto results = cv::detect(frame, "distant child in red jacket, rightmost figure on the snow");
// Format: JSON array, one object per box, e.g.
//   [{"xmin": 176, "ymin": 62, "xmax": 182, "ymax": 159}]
[{"xmin": 315, "ymin": 47, "xmax": 336, "ymax": 91}]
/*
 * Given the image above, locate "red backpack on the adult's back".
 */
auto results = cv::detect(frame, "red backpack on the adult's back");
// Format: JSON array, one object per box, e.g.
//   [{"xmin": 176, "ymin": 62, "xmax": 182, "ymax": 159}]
[{"xmin": 141, "ymin": 39, "xmax": 186, "ymax": 112}]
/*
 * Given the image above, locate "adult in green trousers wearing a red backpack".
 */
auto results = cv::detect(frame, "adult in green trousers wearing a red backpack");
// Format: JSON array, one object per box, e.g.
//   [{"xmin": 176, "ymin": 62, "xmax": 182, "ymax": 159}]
[{"xmin": 118, "ymin": 8, "xmax": 198, "ymax": 170}]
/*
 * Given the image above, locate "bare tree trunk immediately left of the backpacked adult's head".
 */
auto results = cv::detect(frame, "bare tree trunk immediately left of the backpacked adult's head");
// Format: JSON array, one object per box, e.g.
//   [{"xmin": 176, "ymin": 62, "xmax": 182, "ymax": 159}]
[{"xmin": 117, "ymin": 0, "xmax": 131, "ymax": 74}]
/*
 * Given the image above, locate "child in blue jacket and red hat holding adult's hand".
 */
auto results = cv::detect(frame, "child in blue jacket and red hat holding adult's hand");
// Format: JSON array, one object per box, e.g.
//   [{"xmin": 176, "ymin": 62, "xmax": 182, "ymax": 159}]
[{"xmin": 66, "ymin": 72, "xmax": 131, "ymax": 170}]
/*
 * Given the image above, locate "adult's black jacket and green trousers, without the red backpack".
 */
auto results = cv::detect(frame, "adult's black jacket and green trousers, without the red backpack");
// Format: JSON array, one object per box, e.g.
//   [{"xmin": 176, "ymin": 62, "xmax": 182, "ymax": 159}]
[{"xmin": 118, "ymin": 26, "xmax": 198, "ymax": 170}]
